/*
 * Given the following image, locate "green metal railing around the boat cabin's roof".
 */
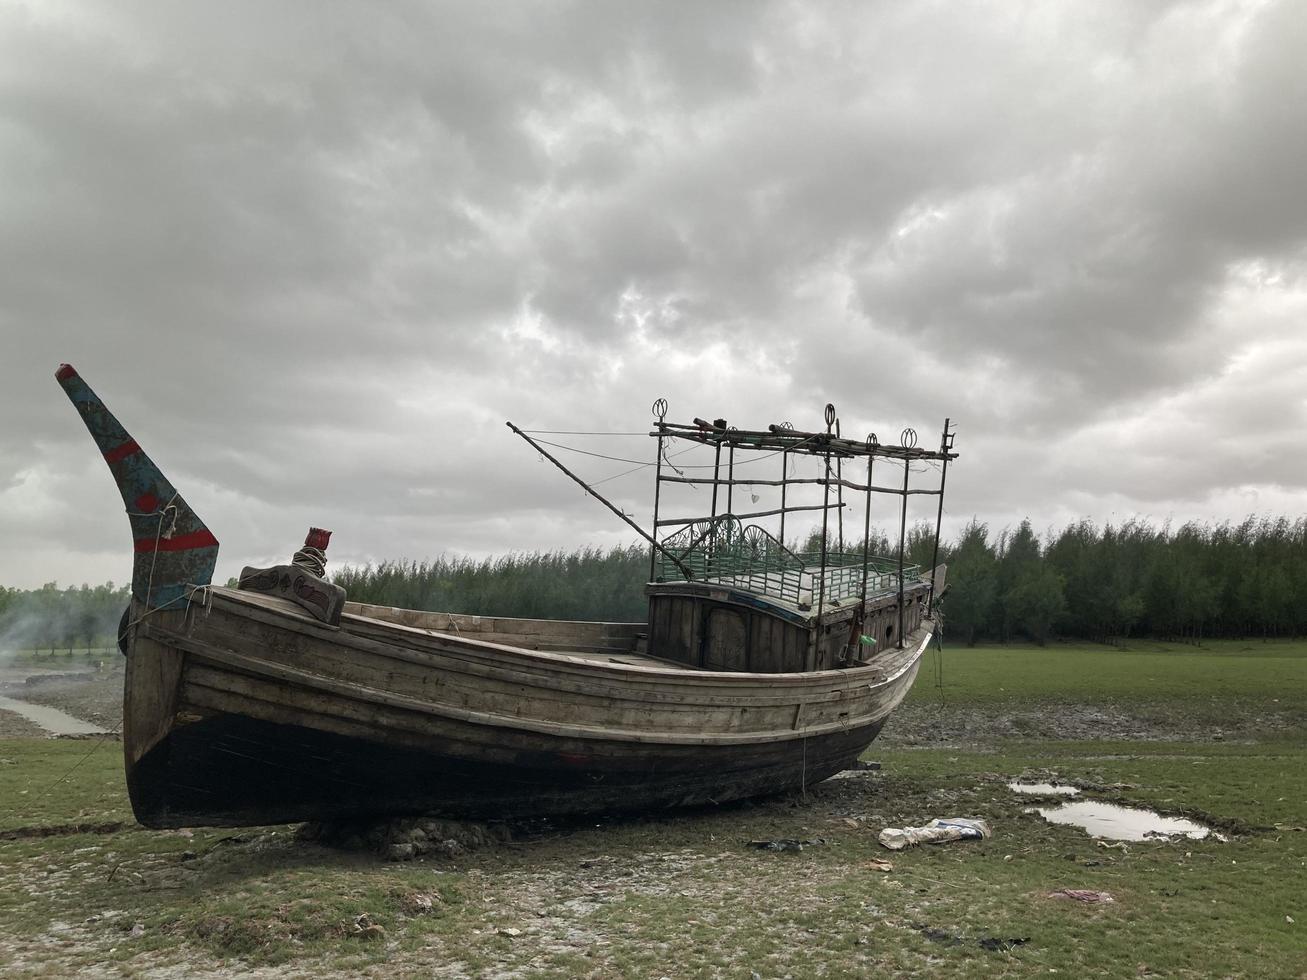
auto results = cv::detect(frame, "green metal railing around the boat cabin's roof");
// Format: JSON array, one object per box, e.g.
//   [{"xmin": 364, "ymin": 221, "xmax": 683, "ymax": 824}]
[{"xmin": 656, "ymin": 516, "xmax": 920, "ymax": 608}]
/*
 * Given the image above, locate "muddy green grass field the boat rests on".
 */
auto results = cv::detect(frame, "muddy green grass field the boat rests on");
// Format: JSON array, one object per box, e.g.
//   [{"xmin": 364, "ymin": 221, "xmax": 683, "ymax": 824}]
[{"xmin": 0, "ymin": 643, "xmax": 1307, "ymax": 977}]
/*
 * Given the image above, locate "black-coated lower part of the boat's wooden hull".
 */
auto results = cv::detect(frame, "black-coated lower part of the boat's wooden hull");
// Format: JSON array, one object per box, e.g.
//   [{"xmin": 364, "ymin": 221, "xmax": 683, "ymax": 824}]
[{"xmin": 127, "ymin": 715, "xmax": 882, "ymax": 827}]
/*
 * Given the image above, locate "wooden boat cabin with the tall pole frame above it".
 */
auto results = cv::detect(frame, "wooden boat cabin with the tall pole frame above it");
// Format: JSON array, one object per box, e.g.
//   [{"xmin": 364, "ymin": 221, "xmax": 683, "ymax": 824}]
[{"xmin": 646, "ymin": 402, "xmax": 955, "ymax": 673}]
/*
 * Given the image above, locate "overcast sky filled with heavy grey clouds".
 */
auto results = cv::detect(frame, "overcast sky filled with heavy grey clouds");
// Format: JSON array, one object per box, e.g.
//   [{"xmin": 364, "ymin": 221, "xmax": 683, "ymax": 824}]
[{"xmin": 0, "ymin": 0, "xmax": 1307, "ymax": 587}]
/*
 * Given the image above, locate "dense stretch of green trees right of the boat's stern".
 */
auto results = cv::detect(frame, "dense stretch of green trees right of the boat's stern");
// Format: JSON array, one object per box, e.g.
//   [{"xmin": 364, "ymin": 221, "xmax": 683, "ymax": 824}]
[{"xmin": 944, "ymin": 517, "xmax": 1307, "ymax": 645}]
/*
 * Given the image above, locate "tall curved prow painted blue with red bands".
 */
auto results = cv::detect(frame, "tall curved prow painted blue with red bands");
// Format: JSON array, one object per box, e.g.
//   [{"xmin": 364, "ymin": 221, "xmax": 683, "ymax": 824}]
[{"xmin": 55, "ymin": 365, "xmax": 218, "ymax": 609}]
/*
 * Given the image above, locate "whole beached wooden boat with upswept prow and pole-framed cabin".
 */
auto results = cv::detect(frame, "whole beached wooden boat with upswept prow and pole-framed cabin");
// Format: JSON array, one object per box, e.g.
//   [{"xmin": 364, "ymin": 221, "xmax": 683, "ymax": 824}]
[{"xmin": 56, "ymin": 365, "xmax": 955, "ymax": 827}]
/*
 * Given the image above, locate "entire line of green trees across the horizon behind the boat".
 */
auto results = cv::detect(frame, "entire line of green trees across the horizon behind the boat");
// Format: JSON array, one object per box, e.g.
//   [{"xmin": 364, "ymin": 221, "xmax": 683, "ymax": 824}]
[{"xmin": 10, "ymin": 517, "xmax": 1307, "ymax": 651}]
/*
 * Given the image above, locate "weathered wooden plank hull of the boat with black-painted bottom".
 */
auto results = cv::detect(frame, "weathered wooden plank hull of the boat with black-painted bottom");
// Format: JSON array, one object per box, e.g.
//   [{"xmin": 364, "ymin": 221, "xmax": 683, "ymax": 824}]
[{"xmin": 124, "ymin": 588, "xmax": 931, "ymax": 827}]
